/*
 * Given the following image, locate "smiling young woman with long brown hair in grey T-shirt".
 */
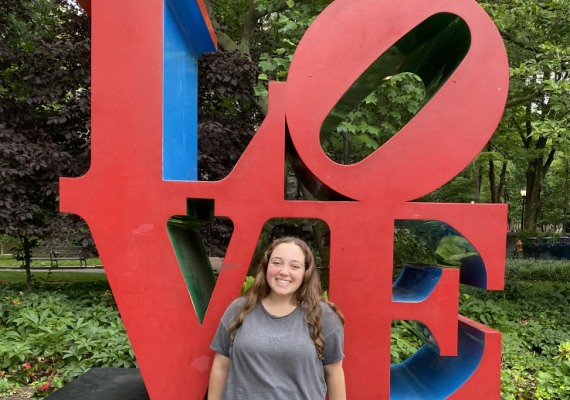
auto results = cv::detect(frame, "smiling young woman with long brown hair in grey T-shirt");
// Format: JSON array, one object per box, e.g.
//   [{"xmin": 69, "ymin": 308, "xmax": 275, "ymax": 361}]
[{"xmin": 208, "ymin": 237, "xmax": 346, "ymax": 400}]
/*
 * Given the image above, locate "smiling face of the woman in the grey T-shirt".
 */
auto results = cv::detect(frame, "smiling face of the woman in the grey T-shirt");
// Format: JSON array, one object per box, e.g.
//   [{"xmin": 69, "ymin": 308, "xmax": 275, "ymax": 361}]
[{"xmin": 266, "ymin": 243, "xmax": 305, "ymax": 297}]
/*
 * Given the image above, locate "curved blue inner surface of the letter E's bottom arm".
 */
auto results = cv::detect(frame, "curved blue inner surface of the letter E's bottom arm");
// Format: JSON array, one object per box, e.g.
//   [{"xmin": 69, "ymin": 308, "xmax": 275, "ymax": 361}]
[{"xmin": 390, "ymin": 324, "xmax": 485, "ymax": 400}]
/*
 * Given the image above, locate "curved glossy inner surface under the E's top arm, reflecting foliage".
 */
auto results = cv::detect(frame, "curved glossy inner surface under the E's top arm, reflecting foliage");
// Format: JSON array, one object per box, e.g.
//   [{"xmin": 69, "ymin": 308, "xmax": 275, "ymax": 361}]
[{"xmin": 395, "ymin": 220, "xmax": 487, "ymax": 289}]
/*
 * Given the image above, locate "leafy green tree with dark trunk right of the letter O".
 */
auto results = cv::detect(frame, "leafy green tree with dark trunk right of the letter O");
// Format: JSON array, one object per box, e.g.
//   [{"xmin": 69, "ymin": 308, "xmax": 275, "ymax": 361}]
[{"xmin": 481, "ymin": 0, "xmax": 570, "ymax": 229}]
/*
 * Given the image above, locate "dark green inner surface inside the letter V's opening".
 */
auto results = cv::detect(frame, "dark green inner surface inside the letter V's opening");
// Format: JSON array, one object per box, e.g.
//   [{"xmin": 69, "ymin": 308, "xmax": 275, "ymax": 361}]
[{"xmin": 166, "ymin": 199, "xmax": 216, "ymax": 324}]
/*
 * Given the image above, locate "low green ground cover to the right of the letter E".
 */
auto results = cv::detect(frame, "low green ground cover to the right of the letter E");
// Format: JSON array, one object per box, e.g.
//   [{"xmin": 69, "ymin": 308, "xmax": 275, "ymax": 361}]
[{"xmin": 459, "ymin": 278, "xmax": 570, "ymax": 400}]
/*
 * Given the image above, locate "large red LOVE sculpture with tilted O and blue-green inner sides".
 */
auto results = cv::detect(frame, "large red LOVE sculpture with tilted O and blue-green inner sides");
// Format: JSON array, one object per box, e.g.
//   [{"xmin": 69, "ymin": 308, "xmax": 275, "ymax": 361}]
[{"xmin": 61, "ymin": 0, "xmax": 509, "ymax": 400}]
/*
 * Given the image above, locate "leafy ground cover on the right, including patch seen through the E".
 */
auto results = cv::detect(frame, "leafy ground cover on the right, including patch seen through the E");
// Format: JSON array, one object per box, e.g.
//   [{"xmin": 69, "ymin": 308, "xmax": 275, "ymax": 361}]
[{"xmin": 391, "ymin": 260, "xmax": 570, "ymax": 400}]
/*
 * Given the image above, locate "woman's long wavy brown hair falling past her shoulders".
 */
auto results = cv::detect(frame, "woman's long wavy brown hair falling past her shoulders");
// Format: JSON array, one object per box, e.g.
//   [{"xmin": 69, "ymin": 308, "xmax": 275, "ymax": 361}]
[{"xmin": 225, "ymin": 236, "xmax": 344, "ymax": 359}]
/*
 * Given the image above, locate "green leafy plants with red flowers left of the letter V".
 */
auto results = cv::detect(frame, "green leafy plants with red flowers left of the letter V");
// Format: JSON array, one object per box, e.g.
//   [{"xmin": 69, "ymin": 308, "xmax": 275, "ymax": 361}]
[{"xmin": 0, "ymin": 283, "xmax": 137, "ymax": 397}]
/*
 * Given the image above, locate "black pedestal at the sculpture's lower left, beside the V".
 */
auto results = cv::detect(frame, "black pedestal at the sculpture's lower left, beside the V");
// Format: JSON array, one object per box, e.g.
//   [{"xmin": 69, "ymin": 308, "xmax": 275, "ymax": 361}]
[{"xmin": 46, "ymin": 368, "xmax": 150, "ymax": 400}]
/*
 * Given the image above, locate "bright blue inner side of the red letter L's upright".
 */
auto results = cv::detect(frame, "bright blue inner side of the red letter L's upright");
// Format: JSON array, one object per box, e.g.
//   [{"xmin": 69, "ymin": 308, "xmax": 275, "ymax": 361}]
[{"xmin": 162, "ymin": 0, "xmax": 216, "ymax": 181}]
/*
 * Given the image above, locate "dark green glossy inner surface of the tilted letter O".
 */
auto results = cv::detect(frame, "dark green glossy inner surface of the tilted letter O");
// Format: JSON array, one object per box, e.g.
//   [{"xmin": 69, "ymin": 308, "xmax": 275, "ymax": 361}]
[{"xmin": 320, "ymin": 13, "xmax": 471, "ymax": 143}]
